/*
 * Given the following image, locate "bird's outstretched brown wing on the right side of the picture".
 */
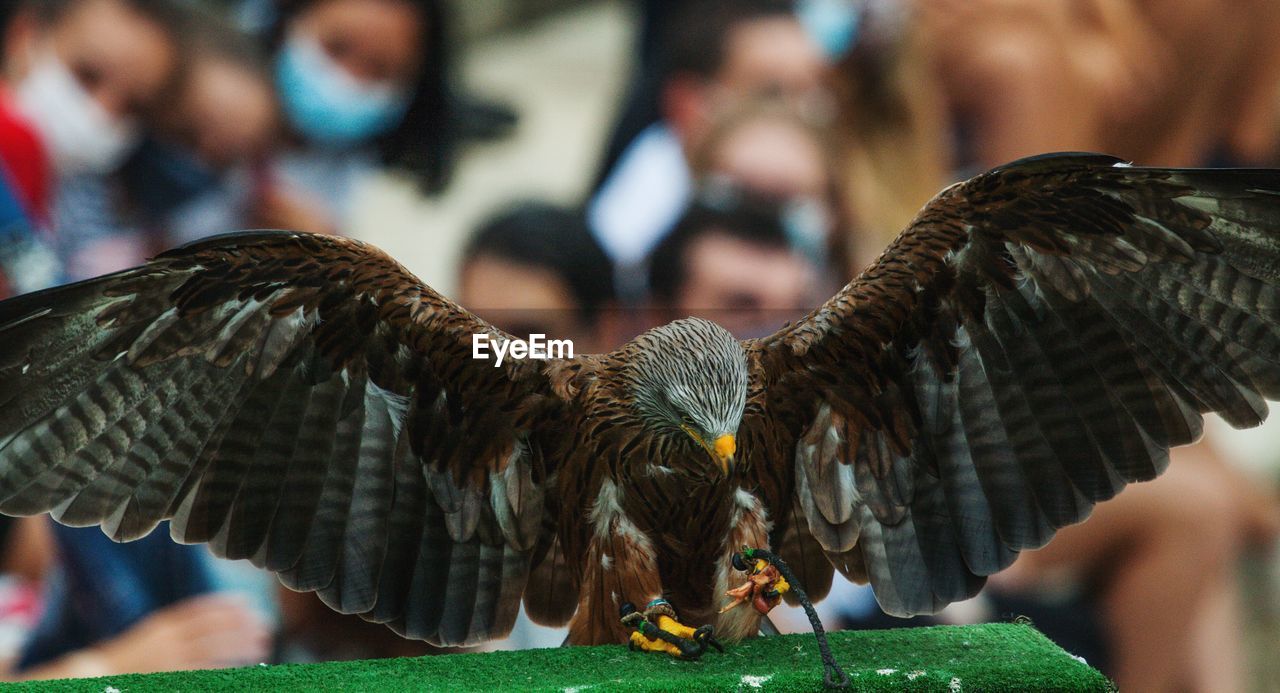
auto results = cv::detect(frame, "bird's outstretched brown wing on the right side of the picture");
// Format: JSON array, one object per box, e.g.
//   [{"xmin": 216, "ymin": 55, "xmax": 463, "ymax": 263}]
[{"xmin": 740, "ymin": 155, "xmax": 1280, "ymax": 615}]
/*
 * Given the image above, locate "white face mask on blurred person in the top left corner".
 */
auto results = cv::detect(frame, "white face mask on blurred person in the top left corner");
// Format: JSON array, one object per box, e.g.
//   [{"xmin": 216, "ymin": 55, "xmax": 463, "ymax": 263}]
[{"xmin": 14, "ymin": 46, "xmax": 140, "ymax": 175}]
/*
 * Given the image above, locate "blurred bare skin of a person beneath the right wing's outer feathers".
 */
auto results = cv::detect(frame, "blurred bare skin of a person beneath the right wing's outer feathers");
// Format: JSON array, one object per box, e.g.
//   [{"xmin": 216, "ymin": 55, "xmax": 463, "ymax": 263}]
[{"xmin": 991, "ymin": 442, "xmax": 1280, "ymax": 692}]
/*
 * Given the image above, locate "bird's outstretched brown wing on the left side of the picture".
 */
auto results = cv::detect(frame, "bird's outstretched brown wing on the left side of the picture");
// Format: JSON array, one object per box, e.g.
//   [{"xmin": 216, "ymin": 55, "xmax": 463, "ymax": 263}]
[{"xmin": 0, "ymin": 232, "xmax": 565, "ymax": 644}]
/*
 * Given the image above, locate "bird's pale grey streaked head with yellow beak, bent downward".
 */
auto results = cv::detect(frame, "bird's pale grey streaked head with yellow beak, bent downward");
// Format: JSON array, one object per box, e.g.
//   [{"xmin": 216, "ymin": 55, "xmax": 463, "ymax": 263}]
[{"xmin": 627, "ymin": 318, "xmax": 746, "ymax": 474}]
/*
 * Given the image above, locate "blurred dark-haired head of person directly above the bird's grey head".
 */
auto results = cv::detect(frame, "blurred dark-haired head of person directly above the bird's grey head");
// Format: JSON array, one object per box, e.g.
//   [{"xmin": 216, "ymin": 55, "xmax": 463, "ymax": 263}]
[{"xmin": 649, "ymin": 183, "xmax": 824, "ymax": 338}]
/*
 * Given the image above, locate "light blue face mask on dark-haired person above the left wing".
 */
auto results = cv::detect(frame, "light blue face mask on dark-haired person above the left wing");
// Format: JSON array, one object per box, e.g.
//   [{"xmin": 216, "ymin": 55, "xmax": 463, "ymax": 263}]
[{"xmin": 275, "ymin": 33, "xmax": 408, "ymax": 146}]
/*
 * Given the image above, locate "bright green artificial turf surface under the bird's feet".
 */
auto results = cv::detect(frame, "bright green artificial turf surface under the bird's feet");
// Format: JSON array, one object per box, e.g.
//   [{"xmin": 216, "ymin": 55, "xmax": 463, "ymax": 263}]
[{"xmin": 12, "ymin": 624, "xmax": 1111, "ymax": 693}]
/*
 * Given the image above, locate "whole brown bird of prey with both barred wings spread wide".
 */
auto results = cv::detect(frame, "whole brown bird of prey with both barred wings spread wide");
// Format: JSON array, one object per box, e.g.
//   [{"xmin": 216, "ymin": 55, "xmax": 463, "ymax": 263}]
[{"xmin": 0, "ymin": 154, "xmax": 1280, "ymax": 649}]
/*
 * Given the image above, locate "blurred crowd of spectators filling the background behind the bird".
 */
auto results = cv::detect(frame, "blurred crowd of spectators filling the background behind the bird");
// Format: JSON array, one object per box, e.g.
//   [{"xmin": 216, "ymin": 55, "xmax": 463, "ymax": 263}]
[{"xmin": 0, "ymin": 0, "xmax": 1280, "ymax": 692}]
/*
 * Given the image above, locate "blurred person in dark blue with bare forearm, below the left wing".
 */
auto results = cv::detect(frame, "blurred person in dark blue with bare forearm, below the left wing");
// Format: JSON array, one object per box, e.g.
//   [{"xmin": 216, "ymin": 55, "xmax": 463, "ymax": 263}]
[{"xmin": 17, "ymin": 518, "xmax": 271, "ymax": 678}]
